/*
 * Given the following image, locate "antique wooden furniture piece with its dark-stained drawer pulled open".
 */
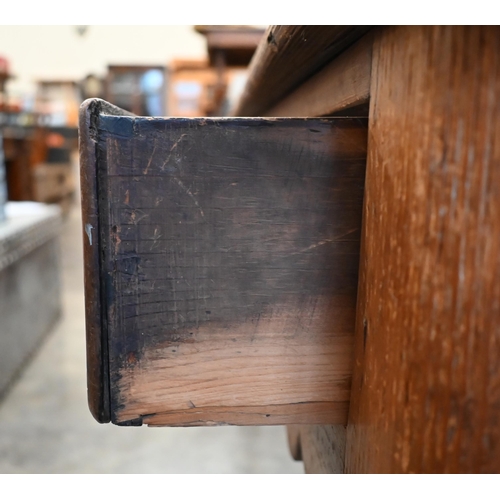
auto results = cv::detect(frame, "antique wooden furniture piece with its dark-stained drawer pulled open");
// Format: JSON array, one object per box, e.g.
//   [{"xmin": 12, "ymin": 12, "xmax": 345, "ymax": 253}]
[{"xmin": 81, "ymin": 26, "xmax": 500, "ymax": 473}]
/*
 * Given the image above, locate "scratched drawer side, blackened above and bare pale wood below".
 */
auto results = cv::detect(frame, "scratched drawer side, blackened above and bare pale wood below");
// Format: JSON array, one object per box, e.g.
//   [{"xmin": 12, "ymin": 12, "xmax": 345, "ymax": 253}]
[{"xmin": 79, "ymin": 100, "xmax": 366, "ymax": 425}]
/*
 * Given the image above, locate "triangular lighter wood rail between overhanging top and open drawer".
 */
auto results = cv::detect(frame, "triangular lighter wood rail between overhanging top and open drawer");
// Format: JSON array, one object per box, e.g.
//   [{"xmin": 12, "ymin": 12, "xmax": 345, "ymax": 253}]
[{"xmin": 266, "ymin": 33, "xmax": 373, "ymax": 117}]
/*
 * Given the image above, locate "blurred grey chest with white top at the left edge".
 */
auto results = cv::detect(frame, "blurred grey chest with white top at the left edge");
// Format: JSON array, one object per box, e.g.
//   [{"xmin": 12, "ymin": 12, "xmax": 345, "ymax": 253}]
[{"xmin": 0, "ymin": 202, "xmax": 61, "ymax": 397}]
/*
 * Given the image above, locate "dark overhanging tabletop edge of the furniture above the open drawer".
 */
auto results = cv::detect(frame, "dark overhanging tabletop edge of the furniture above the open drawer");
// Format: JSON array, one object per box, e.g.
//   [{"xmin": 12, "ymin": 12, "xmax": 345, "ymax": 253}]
[{"xmin": 234, "ymin": 25, "xmax": 371, "ymax": 116}]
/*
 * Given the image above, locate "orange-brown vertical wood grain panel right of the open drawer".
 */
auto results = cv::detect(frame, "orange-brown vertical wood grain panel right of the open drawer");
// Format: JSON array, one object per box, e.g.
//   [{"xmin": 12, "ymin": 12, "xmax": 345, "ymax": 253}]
[{"xmin": 346, "ymin": 26, "xmax": 500, "ymax": 473}]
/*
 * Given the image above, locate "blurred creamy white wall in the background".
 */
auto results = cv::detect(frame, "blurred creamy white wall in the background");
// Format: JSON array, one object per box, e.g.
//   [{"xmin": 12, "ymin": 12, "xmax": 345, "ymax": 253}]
[{"xmin": 0, "ymin": 25, "xmax": 206, "ymax": 97}]
